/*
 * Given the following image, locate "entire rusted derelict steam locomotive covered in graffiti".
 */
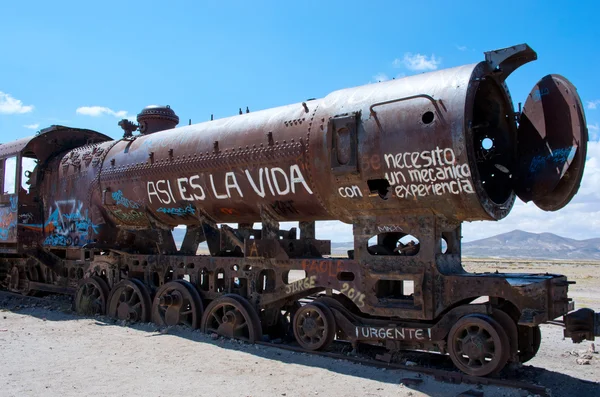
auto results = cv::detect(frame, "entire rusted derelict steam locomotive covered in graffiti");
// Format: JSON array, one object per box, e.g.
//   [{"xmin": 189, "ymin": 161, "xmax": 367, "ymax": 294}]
[{"xmin": 0, "ymin": 44, "xmax": 600, "ymax": 375}]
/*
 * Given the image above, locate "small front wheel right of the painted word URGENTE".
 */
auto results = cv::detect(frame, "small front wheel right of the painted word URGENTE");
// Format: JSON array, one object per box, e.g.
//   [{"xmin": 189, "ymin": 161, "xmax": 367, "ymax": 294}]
[{"xmin": 448, "ymin": 315, "xmax": 510, "ymax": 376}]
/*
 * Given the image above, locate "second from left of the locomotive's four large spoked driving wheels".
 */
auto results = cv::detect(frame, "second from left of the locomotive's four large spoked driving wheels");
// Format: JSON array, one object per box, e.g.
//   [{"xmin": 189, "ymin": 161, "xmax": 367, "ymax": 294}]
[{"xmin": 107, "ymin": 279, "xmax": 152, "ymax": 323}]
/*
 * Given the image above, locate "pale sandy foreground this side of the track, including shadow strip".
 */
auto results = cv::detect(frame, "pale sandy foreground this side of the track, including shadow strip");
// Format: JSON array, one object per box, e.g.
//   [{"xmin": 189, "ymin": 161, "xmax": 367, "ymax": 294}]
[{"xmin": 0, "ymin": 309, "xmax": 527, "ymax": 397}]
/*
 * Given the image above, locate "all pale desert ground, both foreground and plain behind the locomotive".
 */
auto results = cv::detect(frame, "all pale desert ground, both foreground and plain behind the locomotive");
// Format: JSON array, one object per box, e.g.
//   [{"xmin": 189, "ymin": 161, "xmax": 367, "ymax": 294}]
[{"xmin": 0, "ymin": 259, "xmax": 600, "ymax": 397}]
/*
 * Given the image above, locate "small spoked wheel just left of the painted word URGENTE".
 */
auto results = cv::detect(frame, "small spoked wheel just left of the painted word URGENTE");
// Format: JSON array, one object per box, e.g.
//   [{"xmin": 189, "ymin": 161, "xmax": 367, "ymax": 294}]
[{"xmin": 294, "ymin": 302, "xmax": 336, "ymax": 350}]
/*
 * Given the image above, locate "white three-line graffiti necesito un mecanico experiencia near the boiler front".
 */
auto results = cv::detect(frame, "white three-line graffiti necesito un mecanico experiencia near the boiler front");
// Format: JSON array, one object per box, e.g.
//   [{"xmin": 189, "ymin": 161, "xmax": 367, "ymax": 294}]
[{"xmin": 384, "ymin": 146, "xmax": 475, "ymax": 199}]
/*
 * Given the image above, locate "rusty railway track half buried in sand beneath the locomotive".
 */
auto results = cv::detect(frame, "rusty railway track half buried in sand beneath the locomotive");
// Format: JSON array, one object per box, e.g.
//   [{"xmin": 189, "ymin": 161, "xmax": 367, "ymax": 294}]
[{"xmin": 0, "ymin": 291, "xmax": 550, "ymax": 396}]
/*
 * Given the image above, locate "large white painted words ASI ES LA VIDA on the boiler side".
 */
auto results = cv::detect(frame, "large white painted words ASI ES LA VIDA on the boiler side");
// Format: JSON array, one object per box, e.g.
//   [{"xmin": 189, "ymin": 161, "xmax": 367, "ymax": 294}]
[{"xmin": 147, "ymin": 164, "xmax": 313, "ymax": 205}]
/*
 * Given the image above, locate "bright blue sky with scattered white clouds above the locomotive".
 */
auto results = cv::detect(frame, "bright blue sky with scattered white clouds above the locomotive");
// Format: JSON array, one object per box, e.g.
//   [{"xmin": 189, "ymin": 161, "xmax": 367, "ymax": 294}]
[{"xmin": 0, "ymin": 0, "xmax": 600, "ymax": 241}]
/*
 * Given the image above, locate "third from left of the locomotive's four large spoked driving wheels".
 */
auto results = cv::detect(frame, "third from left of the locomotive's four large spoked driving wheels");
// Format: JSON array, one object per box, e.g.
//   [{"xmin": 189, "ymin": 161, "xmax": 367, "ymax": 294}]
[{"xmin": 152, "ymin": 281, "xmax": 202, "ymax": 329}]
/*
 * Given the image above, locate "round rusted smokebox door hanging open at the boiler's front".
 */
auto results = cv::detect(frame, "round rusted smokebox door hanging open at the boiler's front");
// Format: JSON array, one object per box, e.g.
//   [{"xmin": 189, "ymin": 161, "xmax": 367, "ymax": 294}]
[{"xmin": 514, "ymin": 74, "xmax": 588, "ymax": 211}]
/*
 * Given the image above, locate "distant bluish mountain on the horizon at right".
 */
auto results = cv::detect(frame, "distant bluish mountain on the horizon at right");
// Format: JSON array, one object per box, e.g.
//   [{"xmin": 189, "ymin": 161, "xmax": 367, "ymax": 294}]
[{"xmin": 462, "ymin": 230, "xmax": 600, "ymax": 260}]
